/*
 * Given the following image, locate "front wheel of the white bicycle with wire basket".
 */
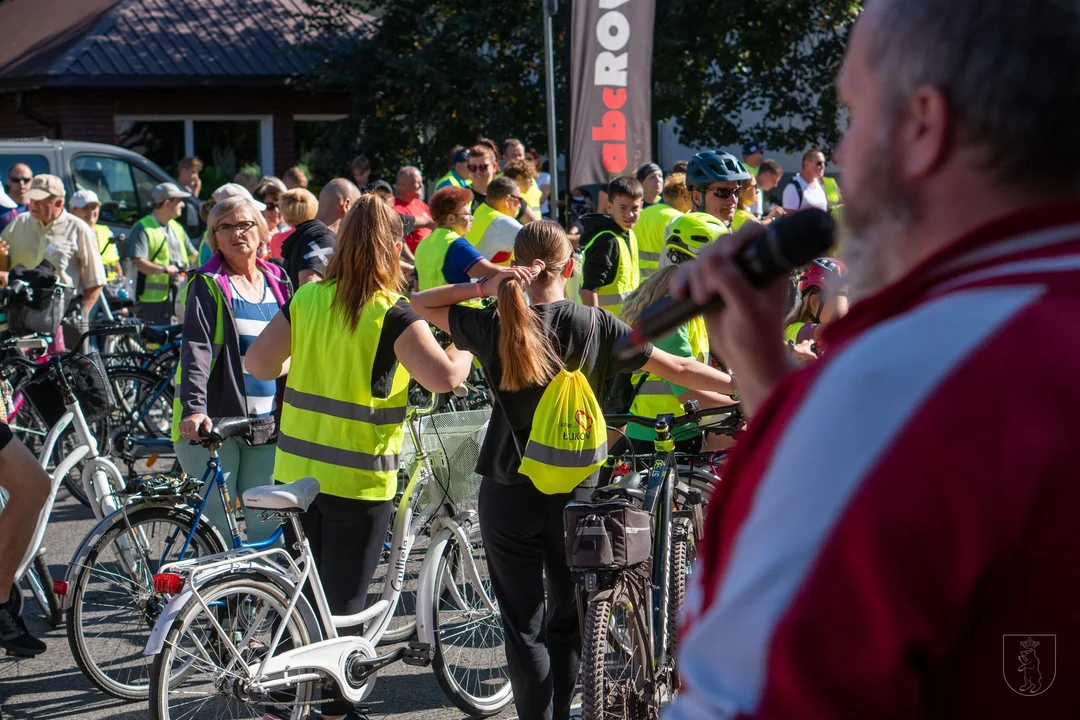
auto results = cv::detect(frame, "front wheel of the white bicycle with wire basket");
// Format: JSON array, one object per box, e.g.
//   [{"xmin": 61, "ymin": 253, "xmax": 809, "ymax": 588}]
[{"xmin": 431, "ymin": 538, "xmax": 513, "ymax": 718}]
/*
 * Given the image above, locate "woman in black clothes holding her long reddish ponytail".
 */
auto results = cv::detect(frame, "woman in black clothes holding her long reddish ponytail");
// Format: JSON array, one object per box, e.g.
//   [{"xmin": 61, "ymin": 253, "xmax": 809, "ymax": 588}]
[{"xmin": 413, "ymin": 220, "xmax": 731, "ymax": 720}]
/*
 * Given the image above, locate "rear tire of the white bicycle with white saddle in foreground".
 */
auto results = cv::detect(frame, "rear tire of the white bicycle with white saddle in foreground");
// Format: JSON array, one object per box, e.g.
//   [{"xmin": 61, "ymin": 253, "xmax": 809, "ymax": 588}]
[{"xmin": 150, "ymin": 573, "xmax": 322, "ymax": 720}]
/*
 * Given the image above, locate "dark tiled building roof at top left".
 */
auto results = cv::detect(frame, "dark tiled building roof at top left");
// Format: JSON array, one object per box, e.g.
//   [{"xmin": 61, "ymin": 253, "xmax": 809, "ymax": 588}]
[{"xmin": 0, "ymin": 0, "xmax": 370, "ymax": 89}]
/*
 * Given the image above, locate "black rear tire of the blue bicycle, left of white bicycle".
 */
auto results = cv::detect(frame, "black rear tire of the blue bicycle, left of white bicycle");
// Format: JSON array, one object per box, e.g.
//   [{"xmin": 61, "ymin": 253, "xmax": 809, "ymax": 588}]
[{"xmin": 67, "ymin": 505, "xmax": 225, "ymax": 699}]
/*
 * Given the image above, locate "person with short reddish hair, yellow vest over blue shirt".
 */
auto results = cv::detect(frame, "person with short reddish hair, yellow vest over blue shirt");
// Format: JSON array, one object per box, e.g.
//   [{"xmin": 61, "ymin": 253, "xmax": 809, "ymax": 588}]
[{"xmin": 416, "ymin": 187, "xmax": 509, "ymax": 290}]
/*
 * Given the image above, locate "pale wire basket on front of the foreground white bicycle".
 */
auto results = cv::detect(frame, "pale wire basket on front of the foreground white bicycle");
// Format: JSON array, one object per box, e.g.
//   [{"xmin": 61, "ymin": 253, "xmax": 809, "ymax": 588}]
[{"xmin": 402, "ymin": 408, "xmax": 491, "ymax": 510}]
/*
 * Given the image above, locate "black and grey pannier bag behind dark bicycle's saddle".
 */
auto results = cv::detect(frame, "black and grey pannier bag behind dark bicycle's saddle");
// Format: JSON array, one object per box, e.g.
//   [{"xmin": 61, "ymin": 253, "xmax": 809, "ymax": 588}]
[{"xmin": 563, "ymin": 501, "xmax": 652, "ymax": 570}]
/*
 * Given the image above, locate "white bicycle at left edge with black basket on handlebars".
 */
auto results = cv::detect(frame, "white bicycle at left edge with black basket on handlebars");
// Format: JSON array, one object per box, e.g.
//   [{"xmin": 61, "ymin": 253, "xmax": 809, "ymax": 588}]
[{"xmin": 0, "ymin": 326, "xmax": 142, "ymax": 627}]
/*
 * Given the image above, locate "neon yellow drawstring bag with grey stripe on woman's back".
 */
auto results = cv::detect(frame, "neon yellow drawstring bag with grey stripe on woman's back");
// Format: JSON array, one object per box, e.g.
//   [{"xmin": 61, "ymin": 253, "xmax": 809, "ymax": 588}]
[{"xmin": 518, "ymin": 308, "xmax": 607, "ymax": 495}]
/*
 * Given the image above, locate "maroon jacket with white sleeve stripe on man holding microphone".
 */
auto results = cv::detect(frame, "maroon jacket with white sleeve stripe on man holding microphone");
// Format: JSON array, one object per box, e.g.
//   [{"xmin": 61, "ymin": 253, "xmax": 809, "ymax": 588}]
[{"xmin": 664, "ymin": 203, "xmax": 1080, "ymax": 720}]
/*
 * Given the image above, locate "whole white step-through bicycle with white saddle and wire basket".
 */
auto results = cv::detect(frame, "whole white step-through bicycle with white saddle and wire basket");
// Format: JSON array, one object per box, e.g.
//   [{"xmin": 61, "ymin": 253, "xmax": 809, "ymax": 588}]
[{"xmin": 146, "ymin": 409, "xmax": 511, "ymax": 718}]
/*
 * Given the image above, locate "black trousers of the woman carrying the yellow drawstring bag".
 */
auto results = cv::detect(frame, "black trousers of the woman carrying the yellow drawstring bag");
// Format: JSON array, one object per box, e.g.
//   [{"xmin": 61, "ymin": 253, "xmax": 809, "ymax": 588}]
[{"xmin": 480, "ymin": 478, "xmax": 581, "ymax": 720}]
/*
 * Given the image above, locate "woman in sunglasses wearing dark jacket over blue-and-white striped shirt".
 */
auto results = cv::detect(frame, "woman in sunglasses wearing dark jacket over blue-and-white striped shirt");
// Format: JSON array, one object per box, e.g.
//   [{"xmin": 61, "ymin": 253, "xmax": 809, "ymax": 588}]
[{"xmin": 173, "ymin": 196, "xmax": 293, "ymax": 541}]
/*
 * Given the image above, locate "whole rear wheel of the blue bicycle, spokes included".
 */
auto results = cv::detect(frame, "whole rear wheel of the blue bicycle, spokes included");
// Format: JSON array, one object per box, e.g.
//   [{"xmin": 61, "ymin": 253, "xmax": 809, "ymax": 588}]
[{"xmin": 67, "ymin": 507, "xmax": 225, "ymax": 699}]
